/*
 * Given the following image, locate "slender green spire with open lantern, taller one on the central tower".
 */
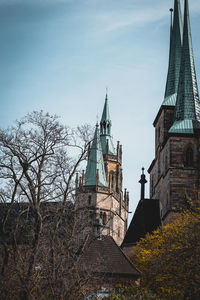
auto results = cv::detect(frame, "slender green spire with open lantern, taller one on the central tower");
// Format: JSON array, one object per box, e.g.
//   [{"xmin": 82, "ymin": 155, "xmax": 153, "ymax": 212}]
[{"xmin": 100, "ymin": 94, "xmax": 115, "ymax": 155}]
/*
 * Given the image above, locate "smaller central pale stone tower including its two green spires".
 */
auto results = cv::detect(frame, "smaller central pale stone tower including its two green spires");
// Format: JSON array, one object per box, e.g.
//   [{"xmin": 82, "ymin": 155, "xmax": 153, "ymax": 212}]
[{"xmin": 76, "ymin": 95, "xmax": 129, "ymax": 245}]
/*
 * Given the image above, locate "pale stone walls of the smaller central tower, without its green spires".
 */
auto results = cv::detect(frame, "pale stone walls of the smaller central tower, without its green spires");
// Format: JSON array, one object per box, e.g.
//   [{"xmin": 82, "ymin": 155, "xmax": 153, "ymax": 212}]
[{"xmin": 76, "ymin": 149, "xmax": 129, "ymax": 245}]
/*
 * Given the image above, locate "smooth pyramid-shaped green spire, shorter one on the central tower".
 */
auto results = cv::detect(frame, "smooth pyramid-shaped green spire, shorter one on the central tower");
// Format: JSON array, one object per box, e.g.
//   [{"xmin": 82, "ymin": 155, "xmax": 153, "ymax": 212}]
[{"xmin": 85, "ymin": 124, "xmax": 108, "ymax": 187}]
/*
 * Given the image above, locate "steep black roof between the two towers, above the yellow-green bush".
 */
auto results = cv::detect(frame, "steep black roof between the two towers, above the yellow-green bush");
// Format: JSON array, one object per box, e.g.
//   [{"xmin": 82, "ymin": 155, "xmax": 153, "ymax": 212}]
[{"xmin": 122, "ymin": 199, "xmax": 161, "ymax": 247}]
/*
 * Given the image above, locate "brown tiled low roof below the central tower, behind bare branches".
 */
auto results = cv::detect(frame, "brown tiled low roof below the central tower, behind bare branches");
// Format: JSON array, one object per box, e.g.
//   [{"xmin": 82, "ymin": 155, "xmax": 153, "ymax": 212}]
[{"xmin": 80, "ymin": 236, "xmax": 140, "ymax": 279}]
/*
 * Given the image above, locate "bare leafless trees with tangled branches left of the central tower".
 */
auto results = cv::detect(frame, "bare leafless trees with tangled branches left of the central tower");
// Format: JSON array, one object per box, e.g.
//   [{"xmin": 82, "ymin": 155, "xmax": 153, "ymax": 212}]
[{"xmin": 0, "ymin": 111, "xmax": 94, "ymax": 299}]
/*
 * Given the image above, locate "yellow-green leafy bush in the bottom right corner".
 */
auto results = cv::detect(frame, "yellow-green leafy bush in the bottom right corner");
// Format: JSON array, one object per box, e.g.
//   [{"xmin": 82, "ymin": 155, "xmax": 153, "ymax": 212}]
[{"xmin": 132, "ymin": 207, "xmax": 200, "ymax": 299}]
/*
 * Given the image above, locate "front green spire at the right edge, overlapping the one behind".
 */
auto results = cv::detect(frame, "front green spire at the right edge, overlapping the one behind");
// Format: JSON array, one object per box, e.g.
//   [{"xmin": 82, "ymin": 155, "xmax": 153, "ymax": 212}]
[{"xmin": 169, "ymin": 0, "xmax": 200, "ymax": 133}]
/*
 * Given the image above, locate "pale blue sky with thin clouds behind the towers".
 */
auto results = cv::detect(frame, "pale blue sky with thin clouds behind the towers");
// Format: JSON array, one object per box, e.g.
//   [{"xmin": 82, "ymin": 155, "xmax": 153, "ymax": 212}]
[{"xmin": 0, "ymin": 0, "xmax": 200, "ymax": 218}]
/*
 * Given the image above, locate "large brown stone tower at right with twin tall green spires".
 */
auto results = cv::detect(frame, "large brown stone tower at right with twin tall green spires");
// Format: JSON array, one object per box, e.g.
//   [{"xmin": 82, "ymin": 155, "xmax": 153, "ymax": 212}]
[{"xmin": 149, "ymin": 0, "xmax": 200, "ymax": 224}]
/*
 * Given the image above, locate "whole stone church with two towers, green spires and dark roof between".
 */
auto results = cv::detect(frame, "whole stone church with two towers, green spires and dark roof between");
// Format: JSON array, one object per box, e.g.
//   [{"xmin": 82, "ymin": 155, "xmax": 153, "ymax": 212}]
[{"xmin": 76, "ymin": 0, "xmax": 200, "ymax": 253}]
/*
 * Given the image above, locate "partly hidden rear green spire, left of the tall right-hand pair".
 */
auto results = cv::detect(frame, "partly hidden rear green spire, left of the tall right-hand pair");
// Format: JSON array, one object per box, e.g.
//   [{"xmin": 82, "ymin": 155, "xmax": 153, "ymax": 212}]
[{"xmin": 162, "ymin": 0, "xmax": 182, "ymax": 106}]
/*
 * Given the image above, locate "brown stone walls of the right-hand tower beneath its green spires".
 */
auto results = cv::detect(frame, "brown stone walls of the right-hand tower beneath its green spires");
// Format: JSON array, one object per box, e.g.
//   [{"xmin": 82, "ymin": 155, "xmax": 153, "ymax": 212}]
[{"xmin": 149, "ymin": 107, "xmax": 200, "ymax": 224}]
